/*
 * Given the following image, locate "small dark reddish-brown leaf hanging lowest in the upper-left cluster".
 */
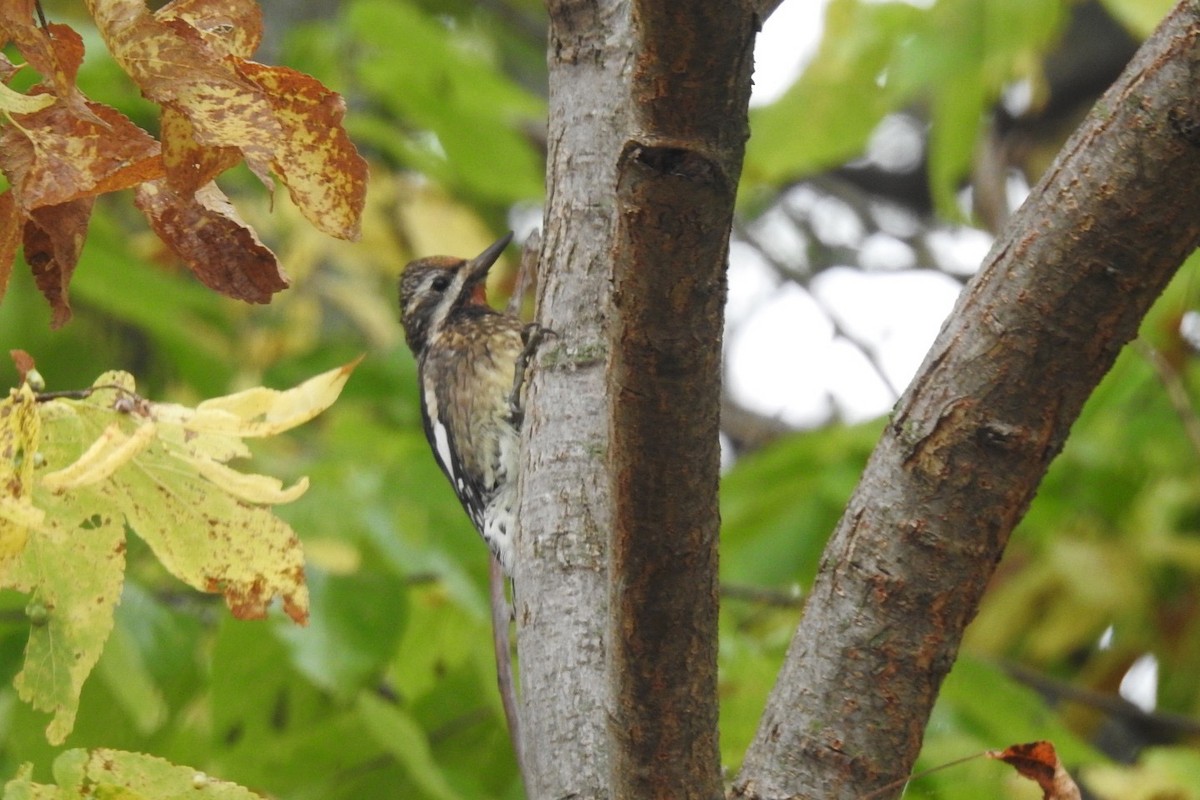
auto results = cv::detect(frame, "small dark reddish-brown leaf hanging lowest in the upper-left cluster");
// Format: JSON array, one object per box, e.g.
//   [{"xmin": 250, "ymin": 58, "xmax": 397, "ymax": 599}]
[{"xmin": 25, "ymin": 197, "xmax": 96, "ymax": 329}]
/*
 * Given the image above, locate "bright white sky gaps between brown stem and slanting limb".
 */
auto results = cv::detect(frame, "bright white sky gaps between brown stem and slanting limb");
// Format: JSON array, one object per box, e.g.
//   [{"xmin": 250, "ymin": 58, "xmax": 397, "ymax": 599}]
[{"xmin": 726, "ymin": 0, "xmax": 990, "ymax": 426}]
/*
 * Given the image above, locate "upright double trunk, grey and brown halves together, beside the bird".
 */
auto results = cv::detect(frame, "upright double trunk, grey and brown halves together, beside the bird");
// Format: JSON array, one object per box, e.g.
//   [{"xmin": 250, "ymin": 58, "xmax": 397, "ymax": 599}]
[{"xmin": 514, "ymin": 0, "xmax": 756, "ymax": 798}]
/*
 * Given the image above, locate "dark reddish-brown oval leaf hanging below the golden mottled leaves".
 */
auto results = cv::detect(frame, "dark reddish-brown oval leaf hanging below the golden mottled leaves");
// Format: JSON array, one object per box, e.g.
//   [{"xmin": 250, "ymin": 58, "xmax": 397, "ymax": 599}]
[{"xmin": 133, "ymin": 180, "xmax": 288, "ymax": 302}]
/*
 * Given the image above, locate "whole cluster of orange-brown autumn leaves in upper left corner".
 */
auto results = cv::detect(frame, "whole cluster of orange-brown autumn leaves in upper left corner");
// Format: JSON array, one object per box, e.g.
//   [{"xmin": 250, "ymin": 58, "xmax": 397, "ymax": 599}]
[{"xmin": 0, "ymin": 0, "xmax": 367, "ymax": 327}]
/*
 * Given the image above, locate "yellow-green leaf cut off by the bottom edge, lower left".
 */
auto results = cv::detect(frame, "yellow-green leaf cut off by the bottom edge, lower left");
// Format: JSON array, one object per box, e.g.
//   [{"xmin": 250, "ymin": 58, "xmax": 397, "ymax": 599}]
[{"xmin": 4, "ymin": 748, "xmax": 259, "ymax": 800}]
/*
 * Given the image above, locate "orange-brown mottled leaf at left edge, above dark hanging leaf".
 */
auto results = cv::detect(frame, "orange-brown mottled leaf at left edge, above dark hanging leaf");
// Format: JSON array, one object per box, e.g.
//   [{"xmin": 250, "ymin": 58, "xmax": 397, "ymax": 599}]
[{"xmin": 0, "ymin": 95, "xmax": 163, "ymax": 213}]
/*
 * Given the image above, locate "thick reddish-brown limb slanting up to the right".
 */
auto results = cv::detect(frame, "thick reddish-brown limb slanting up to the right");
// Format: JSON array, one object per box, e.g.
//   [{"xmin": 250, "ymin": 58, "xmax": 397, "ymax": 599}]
[{"xmin": 734, "ymin": 0, "xmax": 1200, "ymax": 800}]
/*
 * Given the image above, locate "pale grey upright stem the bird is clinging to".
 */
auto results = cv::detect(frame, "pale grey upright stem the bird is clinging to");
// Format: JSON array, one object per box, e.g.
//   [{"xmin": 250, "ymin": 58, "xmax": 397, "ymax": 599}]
[{"xmin": 514, "ymin": 0, "xmax": 634, "ymax": 800}]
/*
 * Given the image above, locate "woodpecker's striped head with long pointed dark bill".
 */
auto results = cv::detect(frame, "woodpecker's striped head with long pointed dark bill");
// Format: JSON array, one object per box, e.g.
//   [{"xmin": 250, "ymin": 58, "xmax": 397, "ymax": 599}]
[{"xmin": 400, "ymin": 233, "xmax": 512, "ymax": 356}]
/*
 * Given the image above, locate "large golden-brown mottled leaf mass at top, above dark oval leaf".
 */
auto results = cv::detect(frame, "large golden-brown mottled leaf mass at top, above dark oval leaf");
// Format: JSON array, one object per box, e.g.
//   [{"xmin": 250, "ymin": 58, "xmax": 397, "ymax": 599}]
[{"xmin": 89, "ymin": 0, "xmax": 367, "ymax": 241}]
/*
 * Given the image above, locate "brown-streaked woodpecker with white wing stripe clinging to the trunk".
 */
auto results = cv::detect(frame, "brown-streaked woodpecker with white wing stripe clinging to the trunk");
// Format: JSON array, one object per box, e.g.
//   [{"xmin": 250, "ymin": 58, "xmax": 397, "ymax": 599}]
[{"xmin": 400, "ymin": 234, "xmax": 540, "ymax": 576}]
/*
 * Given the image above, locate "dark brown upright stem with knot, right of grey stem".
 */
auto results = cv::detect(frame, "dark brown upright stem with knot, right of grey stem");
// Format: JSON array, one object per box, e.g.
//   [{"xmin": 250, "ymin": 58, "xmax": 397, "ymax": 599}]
[{"xmin": 608, "ymin": 0, "xmax": 756, "ymax": 800}]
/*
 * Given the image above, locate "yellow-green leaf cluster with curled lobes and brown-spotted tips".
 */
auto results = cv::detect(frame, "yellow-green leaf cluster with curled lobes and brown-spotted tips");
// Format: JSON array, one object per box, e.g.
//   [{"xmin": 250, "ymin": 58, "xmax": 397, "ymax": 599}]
[{"xmin": 0, "ymin": 365, "xmax": 354, "ymax": 744}]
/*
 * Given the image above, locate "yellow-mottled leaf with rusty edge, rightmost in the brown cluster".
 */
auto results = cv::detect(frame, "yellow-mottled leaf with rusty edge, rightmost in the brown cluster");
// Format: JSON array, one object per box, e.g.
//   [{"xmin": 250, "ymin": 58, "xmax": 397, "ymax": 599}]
[{"xmin": 235, "ymin": 60, "xmax": 367, "ymax": 240}]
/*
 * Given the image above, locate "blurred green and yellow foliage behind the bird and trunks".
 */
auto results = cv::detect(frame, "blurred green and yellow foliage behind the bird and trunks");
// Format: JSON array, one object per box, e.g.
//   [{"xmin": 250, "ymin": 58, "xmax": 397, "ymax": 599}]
[{"xmin": 0, "ymin": 0, "xmax": 1200, "ymax": 800}]
